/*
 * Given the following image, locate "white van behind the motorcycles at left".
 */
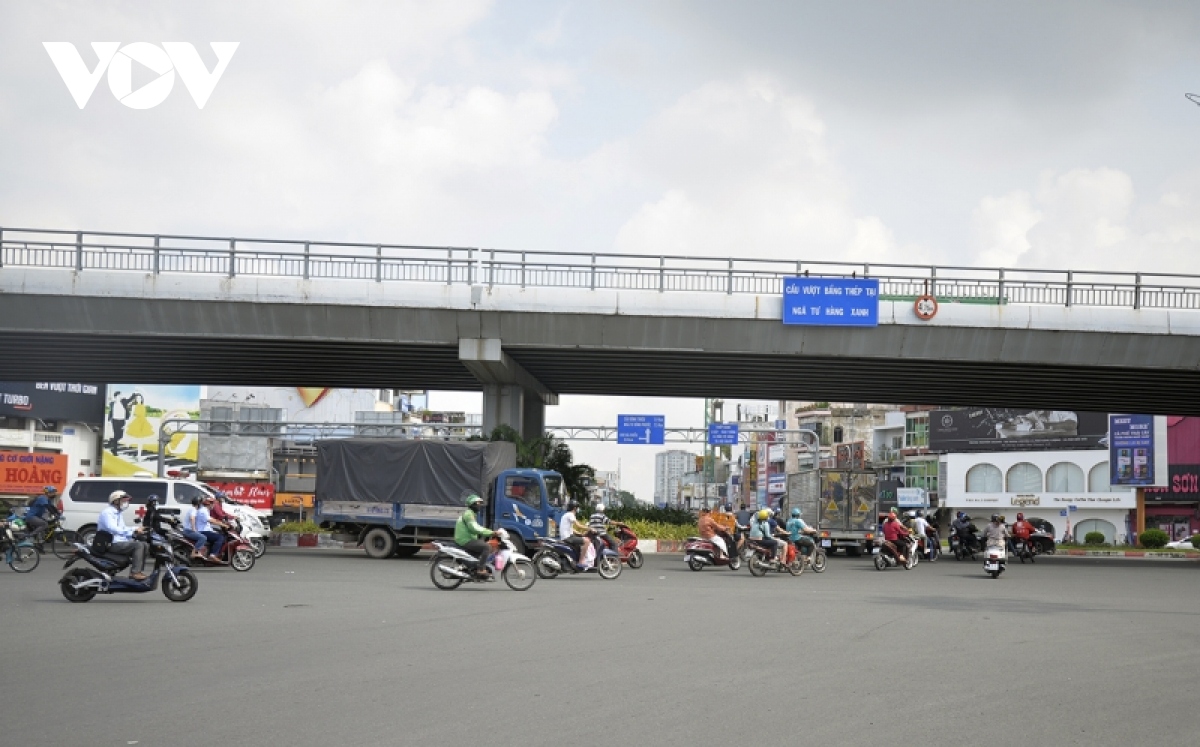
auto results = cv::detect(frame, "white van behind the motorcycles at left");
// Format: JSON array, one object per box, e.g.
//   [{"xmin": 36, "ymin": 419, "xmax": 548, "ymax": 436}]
[{"xmin": 62, "ymin": 477, "xmax": 269, "ymax": 544}]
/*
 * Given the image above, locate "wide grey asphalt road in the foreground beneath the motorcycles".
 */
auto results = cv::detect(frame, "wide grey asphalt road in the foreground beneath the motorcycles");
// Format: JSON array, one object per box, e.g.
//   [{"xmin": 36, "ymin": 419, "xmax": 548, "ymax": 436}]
[{"xmin": 0, "ymin": 549, "xmax": 1200, "ymax": 747}]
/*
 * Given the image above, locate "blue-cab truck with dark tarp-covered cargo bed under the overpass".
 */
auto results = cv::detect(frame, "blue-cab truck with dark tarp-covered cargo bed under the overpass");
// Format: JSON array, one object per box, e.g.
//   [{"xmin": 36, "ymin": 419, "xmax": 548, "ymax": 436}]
[{"xmin": 314, "ymin": 438, "xmax": 565, "ymax": 557}]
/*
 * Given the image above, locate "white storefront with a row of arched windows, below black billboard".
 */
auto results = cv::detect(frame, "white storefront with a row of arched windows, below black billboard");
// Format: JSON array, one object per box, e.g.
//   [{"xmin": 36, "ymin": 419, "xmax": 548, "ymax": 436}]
[{"xmin": 941, "ymin": 449, "xmax": 1138, "ymax": 544}]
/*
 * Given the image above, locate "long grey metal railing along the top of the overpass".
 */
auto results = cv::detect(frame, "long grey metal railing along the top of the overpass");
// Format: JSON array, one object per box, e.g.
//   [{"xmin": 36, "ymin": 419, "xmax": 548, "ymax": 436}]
[{"xmin": 0, "ymin": 227, "xmax": 1200, "ymax": 310}]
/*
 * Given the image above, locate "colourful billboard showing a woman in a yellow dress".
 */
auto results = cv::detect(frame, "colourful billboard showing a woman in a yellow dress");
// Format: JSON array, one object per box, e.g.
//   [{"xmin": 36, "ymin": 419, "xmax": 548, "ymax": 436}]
[{"xmin": 101, "ymin": 384, "xmax": 200, "ymax": 477}]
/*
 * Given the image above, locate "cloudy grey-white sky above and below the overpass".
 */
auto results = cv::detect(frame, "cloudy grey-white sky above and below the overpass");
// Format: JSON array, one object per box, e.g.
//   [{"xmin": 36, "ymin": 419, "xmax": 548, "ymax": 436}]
[{"xmin": 0, "ymin": 0, "xmax": 1200, "ymax": 504}]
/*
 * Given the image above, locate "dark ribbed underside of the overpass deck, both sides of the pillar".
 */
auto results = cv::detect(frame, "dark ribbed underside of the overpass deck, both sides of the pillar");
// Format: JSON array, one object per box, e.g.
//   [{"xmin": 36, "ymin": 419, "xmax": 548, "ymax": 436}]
[{"xmin": 0, "ymin": 331, "xmax": 1200, "ymax": 416}]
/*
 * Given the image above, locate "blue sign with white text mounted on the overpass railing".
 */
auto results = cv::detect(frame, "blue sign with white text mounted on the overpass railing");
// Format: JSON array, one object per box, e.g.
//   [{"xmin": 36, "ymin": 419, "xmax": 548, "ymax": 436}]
[{"xmin": 784, "ymin": 277, "xmax": 880, "ymax": 327}]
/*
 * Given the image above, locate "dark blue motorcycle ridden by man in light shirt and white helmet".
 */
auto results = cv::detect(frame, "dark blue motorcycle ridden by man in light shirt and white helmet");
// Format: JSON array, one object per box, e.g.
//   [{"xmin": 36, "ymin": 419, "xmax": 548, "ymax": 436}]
[{"xmin": 59, "ymin": 532, "xmax": 199, "ymax": 602}]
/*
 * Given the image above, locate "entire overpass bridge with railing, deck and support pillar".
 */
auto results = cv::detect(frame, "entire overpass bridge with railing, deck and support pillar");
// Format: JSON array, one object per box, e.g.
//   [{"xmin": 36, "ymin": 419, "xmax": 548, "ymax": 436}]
[{"xmin": 0, "ymin": 228, "xmax": 1200, "ymax": 439}]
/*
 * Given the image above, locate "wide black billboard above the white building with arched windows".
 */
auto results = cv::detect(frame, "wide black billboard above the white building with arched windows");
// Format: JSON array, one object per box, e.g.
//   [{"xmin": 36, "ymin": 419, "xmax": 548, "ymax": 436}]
[{"xmin": 929, "ymin": 407, "xmax": 1109, "ymax": 453}]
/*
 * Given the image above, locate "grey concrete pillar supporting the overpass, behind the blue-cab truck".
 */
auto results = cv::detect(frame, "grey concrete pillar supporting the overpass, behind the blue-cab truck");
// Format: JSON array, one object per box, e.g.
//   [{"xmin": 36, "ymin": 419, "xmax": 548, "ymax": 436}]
[{"xmin": 458, "ymin": 337, "xmax": 558, "ymax": 438}]
